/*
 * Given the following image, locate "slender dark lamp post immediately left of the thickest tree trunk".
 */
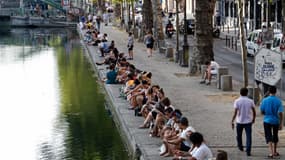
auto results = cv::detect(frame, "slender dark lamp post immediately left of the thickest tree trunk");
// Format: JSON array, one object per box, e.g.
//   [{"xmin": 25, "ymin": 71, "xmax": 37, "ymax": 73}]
[{"xmin": 180, "ymin": 0, "xmax": 189, "ymax": 67}]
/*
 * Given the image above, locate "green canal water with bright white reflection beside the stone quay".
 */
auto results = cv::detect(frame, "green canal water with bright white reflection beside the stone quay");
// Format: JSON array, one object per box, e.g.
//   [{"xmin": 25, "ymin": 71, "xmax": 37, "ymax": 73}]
[{"xmin": 0, "ymin": 29, "xmax": 129, "ymax": 160}]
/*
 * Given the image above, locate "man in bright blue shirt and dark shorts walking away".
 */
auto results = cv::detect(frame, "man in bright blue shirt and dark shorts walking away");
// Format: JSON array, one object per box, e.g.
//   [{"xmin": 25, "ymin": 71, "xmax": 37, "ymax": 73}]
[{"xmin": 260, "ymin": 86, "xmax": 284, "ymax": 158}]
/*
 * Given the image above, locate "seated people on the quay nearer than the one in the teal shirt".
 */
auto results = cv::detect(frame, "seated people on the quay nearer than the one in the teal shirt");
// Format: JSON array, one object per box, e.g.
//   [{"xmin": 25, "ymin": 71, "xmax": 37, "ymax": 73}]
[{"xmin": 121, "ymin": 72, "xmax": 213, "ymax": 160}]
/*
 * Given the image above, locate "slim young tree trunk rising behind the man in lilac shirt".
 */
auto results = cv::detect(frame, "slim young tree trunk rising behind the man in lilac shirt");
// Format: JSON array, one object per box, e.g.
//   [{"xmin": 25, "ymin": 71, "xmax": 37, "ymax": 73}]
[{"xmin": 238, "ymin": 0, "xmax": 248, "ymax": 87}]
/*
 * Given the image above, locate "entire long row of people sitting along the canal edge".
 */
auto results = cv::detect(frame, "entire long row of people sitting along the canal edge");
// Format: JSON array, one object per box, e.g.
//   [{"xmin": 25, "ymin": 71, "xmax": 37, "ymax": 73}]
[{"xmin": 80, "ymin": 23, "xmax": 226, "ymax": 160}]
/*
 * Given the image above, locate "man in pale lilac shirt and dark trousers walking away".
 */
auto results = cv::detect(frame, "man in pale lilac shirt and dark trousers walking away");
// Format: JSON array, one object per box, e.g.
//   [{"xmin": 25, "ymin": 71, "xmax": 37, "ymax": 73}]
[{"xmin": 232, "ymin": 88, "xmax": 256, "ymax": 156}]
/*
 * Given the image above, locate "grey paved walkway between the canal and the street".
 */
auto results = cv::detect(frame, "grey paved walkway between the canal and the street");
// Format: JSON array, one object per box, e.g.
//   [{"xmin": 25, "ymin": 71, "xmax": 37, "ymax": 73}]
[{"xmin": 79, "ymin": 26, "xmax": 285, "ymax": 160}]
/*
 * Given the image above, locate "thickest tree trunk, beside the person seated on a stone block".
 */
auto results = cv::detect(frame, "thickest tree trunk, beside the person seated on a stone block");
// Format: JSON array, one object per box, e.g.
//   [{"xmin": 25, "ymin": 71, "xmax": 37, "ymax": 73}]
[{"xmin": 189, "ymin": 0, "xmax": 216, "ymax": 75}]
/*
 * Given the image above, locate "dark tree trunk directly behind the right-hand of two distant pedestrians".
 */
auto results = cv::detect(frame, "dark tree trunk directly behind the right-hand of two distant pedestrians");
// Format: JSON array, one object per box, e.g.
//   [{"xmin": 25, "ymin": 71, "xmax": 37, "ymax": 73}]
[{"xmin": 140, "ymin": 0, "xmax": 153, "ymax": 40}]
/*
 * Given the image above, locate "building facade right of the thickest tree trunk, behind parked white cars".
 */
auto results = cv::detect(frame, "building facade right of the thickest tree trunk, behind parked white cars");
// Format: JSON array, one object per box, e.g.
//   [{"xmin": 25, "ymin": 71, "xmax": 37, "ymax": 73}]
[{"xmin": 216, "ymin": 0, "xmax": 282, "ymax": 30}]
